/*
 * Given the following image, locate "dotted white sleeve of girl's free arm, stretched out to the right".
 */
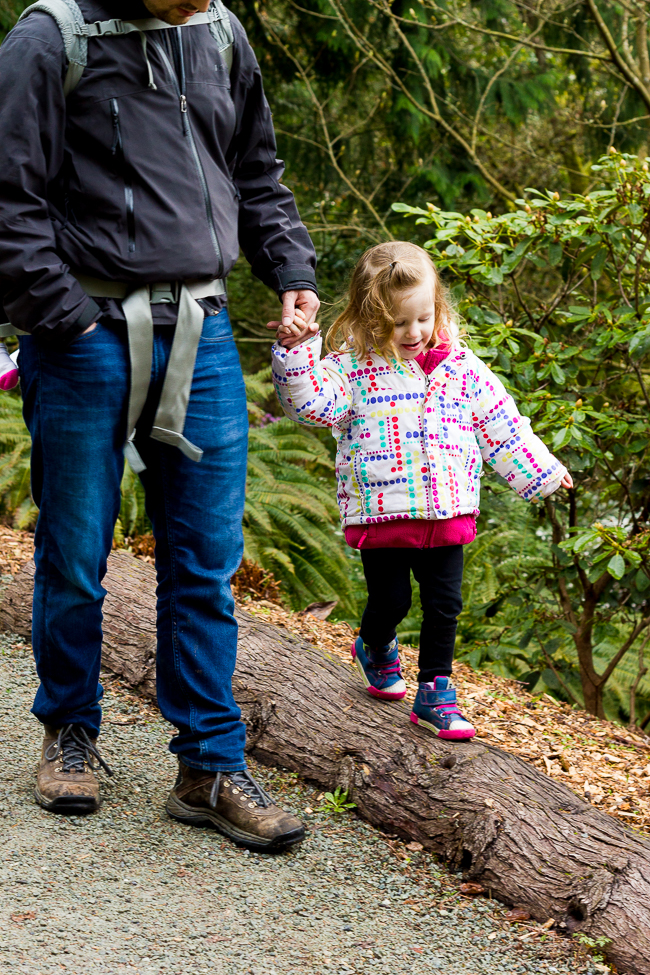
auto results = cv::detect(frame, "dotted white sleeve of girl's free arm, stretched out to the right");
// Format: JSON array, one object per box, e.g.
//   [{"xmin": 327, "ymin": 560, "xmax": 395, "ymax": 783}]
[{"xmin": 473, "ymin": 359, "xmax": 567, "ymax": 501}]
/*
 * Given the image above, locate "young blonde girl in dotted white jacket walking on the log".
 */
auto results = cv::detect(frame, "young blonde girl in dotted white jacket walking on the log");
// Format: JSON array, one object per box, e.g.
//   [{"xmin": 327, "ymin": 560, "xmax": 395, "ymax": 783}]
[{"xmin": 273, "ymin": 241, "xmax": 572, "ymax": 739}]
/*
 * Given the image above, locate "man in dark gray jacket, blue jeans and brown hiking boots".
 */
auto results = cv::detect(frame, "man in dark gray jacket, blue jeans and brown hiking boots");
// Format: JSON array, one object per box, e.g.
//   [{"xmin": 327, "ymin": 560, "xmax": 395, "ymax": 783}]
[{"xmin": 0, "ymin": 0, "xmax": 318, "ymax": 850}]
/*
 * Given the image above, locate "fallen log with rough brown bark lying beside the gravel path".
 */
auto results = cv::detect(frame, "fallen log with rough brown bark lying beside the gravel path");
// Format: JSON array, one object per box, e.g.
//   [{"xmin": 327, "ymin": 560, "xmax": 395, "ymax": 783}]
[{"xmin": 0, "ymin": 553, "xmax": 650, "ymax": 975}]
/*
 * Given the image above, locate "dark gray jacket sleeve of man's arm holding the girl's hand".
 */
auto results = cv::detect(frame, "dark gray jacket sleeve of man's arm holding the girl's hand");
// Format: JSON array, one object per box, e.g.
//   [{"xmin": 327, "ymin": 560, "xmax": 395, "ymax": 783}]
[{"xmin": 230, "ymin": 13, "xmax": 317, "ymax": 294}]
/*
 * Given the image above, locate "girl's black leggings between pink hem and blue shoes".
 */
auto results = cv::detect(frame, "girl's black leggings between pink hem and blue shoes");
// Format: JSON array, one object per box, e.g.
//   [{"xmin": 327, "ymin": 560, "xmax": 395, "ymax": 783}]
[{"xmin": 360, "ymin": 545, "xmax": 463, "ymax": 681}]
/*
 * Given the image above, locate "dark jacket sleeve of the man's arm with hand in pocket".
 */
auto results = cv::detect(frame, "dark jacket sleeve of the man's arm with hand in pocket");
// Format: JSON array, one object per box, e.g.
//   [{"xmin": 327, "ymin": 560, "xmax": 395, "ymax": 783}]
[{"xmin": 0, "ymin": 13, "xmax": 99, "ymax": 342}]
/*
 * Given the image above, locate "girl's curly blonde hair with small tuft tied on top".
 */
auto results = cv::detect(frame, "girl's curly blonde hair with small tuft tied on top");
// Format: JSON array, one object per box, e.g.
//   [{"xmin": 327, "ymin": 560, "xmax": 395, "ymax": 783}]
[{"xmin": 327, "ymin": 240, "xmax": 458, "ymax": 359}]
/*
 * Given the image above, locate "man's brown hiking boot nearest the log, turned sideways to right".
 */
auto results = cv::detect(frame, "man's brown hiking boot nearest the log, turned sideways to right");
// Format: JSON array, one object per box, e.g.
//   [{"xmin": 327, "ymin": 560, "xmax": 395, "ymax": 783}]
[{"xmin": 166, "ymin": 761, "xmax": 305, "ymax": 853}]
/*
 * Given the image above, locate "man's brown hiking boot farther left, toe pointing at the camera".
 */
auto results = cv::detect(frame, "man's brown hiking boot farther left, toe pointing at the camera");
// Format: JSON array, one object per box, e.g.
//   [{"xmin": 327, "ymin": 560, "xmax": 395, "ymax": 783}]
[{"xmin": 34, "ymin": 724, "xmax": 113, "ymax": 816}]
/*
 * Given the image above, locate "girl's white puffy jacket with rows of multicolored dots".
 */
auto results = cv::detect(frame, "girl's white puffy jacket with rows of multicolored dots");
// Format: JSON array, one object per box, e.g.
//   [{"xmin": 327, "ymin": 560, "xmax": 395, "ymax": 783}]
[{"xmin": 273, "ymin": 336, "xmax": 566, "ymax": 528}]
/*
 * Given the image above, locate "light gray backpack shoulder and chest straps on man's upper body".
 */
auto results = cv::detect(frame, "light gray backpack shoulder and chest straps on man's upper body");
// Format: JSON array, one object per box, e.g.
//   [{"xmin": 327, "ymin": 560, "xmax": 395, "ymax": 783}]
[{"xmin": 18, "ymin": 0, "xmax": 234, "ymax": 97}]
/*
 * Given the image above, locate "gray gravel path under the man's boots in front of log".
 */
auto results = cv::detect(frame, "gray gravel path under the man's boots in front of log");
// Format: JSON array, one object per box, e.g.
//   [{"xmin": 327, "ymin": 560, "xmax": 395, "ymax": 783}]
[{"xmin": 0, "ymin": 637, "xmax": 607, "ymax": 975}]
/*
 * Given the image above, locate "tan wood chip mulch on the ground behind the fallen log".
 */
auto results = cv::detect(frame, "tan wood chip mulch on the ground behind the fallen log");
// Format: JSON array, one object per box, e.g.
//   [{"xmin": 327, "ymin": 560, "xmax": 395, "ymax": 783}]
[{"xmin": 0, "ymin": 525, "xmax": 650, "ymax": 833}]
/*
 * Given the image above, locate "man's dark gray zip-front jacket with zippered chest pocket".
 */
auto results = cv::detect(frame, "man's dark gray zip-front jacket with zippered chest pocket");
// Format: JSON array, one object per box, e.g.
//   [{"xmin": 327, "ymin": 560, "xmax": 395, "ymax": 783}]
[{"xmin": 0, "ymin": 0, "xmax": 315, "ymax": 340}]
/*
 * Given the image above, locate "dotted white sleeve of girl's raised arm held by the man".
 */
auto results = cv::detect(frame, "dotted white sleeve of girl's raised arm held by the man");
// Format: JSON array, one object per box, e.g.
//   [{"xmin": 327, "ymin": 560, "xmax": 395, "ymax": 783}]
[{"xmin": 273, "ymin": 335, "xmax": 352, "ymax": 427}]
